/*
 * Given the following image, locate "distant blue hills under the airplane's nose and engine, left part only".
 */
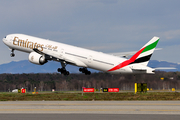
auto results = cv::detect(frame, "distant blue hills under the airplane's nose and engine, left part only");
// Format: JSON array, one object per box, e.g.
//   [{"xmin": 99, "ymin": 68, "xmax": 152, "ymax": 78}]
[{"xmin": 0, "ymin": 60, "xmax": 98, "ymax": 74}]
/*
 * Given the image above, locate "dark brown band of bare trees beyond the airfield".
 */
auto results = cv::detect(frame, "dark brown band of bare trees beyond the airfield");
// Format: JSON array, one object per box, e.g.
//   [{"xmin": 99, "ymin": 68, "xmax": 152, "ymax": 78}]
[{"xmin": 0, "ymin": 72, "xmax": 180, "ymax": 92}]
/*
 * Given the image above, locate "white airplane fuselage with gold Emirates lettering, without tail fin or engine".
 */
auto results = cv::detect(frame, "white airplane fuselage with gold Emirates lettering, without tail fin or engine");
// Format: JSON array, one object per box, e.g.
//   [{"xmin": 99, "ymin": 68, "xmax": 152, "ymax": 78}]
[{"xmin": 3, "ymin": 34, "xmax": 151, "ymax": 73}]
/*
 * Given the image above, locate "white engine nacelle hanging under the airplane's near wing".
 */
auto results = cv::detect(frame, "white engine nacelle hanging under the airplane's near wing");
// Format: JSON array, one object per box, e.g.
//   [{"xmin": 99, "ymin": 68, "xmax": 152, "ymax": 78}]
[{"xmin": 29, "ymin": 52, "xmax": 47, "ymax": 65}]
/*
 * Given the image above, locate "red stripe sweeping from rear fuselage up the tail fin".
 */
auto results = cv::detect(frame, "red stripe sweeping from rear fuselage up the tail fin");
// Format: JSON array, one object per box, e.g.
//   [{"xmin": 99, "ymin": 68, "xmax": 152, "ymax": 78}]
[{"xmin": 108, "ymin": 47, "xmax": 146, "ymax": 71}]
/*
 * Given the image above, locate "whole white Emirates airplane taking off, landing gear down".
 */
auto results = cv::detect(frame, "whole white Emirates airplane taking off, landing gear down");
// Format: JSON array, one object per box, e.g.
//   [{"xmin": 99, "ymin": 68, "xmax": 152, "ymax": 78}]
[{"xmin": 3, "ymin": 34, "xmax": 172, "ymax": 75}]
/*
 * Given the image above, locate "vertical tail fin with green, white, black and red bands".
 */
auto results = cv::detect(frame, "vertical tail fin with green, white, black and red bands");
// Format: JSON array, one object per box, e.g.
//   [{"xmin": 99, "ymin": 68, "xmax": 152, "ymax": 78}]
[{"xmin": 130, "ymin": 37, "xmax": 159, "ymax": 66}]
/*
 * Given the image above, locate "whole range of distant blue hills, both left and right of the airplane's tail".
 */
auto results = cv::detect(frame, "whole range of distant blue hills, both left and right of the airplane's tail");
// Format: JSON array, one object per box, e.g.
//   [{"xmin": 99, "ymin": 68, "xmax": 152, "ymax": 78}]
[{"xmin": 0, "ymin": 60, "xmax": 180, "ymax": 74}]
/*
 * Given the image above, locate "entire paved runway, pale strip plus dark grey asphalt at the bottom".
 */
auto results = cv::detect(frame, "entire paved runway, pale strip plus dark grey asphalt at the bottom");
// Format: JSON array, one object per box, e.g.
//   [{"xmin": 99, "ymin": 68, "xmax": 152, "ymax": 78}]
[{"xmin": 0, "ymin": 101, "xmax": 180, "ymax": 120}]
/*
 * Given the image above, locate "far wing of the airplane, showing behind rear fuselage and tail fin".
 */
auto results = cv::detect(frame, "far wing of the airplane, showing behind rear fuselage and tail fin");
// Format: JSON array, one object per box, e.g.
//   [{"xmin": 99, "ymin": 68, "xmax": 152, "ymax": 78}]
[{"xmin": 110, "ymin": 48, "xmax": 162, "ymax": 58}]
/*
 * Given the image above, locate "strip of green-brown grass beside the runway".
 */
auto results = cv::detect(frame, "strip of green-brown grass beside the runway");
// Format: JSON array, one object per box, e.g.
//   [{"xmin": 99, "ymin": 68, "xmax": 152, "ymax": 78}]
[{"xmin": 0, "ymin": 92, "xmax": 180, "ymax": 101}]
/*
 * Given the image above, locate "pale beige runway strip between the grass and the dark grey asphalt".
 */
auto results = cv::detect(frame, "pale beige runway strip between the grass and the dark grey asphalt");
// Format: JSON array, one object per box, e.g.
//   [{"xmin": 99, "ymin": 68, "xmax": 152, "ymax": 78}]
[{"xmin": 0, "ymin": 101, "xmax": 180, "ymax": 115}]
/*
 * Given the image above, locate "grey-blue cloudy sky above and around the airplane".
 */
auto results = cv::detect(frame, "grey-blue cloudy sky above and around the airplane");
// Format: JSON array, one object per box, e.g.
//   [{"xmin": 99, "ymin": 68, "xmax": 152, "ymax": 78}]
[{"xmin": 0, "ymin": 0, "xmax": 180, "ymax": 64}]
